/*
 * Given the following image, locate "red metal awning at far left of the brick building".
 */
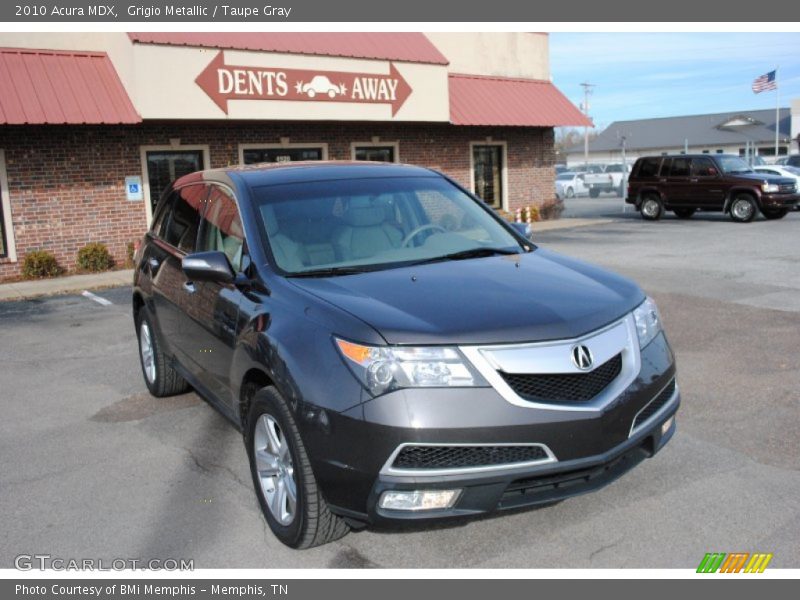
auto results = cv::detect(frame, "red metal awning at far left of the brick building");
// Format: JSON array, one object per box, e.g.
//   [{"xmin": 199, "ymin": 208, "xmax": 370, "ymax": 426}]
[{"xmin": 0, "ymin": 48, "xmax": 142, "ymax": 125}]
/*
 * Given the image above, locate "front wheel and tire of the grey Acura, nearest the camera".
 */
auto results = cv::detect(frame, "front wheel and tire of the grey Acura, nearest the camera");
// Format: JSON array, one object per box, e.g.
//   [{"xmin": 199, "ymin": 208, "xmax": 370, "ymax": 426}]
[{"xmin": 245, "ymin": 386, "xmax": 350, "ymax": 548}]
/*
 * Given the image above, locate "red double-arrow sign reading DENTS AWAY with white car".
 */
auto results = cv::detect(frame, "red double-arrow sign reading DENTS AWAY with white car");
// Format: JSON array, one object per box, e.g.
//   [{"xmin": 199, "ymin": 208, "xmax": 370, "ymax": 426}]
[{"xmin": 195, "ymin": 52, "xmax": 413, "ymax": 116}]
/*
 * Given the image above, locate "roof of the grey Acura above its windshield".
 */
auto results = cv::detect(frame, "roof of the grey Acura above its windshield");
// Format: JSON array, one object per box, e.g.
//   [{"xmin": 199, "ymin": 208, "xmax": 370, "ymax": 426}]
[{"xmin": 181, "ymin": 160, "xmax": 439, "ymax": 186}]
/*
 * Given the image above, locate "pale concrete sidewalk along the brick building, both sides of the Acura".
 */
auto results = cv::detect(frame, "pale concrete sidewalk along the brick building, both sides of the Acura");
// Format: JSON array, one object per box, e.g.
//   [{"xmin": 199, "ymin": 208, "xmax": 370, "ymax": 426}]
[{"xmin": 0, "ymin": 219, "xmax": 614, "ymax": 301}]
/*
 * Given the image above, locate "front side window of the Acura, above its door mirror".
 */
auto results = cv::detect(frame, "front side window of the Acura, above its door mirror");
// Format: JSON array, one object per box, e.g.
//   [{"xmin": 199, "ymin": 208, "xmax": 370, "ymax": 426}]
[{"xmin": 198, "ymin": 185, "xmax": 244, "ymax": 271}]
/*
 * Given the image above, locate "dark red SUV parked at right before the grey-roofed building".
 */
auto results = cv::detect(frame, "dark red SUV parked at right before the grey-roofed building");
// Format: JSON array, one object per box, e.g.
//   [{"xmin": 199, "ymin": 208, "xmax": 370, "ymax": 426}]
[{"xmin": 625, "ymin": 154, "xmax": 800, "ymax": 223}]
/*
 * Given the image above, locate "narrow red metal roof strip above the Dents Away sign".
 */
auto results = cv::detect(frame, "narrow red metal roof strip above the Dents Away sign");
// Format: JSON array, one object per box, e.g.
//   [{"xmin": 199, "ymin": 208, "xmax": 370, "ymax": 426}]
[{"xmin": 128, "ymin": 32, "xmax": 448, "ymax": 65}]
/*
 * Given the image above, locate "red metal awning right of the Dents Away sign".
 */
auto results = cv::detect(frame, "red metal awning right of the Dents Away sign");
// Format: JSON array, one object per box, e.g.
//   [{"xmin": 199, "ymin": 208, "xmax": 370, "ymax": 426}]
[{"xmin": 449, "ymin": 74, "xmax": 591, "ymax": 127}]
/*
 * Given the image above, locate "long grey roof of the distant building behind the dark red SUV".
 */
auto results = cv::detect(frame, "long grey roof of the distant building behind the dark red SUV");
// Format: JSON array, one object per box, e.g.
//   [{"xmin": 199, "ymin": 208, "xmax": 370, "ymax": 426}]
[{"xmin": 567, "ymin": 108, "xmax": 791, "ymax": 153}]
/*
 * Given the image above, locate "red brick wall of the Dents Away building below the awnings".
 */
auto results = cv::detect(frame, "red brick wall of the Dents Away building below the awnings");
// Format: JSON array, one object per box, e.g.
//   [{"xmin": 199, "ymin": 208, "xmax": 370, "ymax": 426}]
[{"xmin": 0, "ymin": 122, "xmax": 555, "ymax": 280}]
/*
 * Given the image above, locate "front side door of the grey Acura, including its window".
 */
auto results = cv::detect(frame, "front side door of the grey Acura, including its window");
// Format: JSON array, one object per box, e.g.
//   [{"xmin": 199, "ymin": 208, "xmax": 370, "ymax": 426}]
[{"xmin": 193, "ymin": 183, "xmax": 248, "ymax": 408}]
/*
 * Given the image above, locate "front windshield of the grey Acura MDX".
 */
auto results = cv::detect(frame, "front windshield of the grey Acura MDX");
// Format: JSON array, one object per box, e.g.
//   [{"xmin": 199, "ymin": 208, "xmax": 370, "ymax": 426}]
[{"xmin": 253, "ymin": 177, "xmax": 522, "ymax": 276}]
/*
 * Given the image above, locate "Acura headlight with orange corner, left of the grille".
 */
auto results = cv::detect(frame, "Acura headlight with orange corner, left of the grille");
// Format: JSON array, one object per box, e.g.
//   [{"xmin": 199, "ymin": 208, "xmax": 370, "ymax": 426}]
[{"xmin": 334, "ymin": 338, "xmax": 489, "ymax": 396}]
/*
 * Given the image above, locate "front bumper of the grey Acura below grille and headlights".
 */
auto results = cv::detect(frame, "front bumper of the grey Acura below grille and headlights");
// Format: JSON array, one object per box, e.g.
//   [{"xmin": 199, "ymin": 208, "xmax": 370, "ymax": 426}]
[{"xmin": 304, "ymin": 334, "xmax": 680, "ymax": 523}]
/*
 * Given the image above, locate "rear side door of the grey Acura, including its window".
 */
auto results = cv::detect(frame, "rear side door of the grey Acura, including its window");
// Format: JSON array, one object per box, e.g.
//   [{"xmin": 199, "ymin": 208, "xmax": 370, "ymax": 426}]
[{"xmin": 145, "ymin": 184, "xmax": 206, "ymax": 374}]
